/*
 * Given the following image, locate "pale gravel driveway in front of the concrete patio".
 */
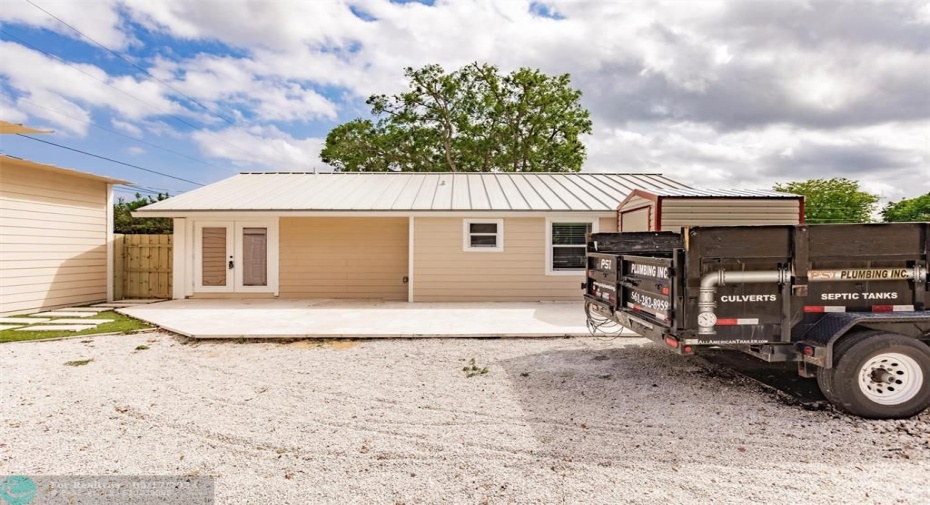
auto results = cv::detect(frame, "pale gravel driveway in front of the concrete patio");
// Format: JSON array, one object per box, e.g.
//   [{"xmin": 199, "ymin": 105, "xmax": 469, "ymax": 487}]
[{"xmin": 0, "ymin": 334, "xmax": 930, "ymax": 504}]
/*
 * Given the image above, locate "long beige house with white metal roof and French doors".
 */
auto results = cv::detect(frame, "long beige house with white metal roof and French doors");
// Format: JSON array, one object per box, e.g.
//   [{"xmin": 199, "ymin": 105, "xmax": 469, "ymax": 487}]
[{"xmin": 134, "ymin": 173, "xmax": 685, "ymax": 302}]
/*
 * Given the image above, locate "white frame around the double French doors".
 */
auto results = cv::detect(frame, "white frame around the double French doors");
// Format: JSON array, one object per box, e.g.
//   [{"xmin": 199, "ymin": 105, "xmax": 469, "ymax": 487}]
[{"xmin": 191, "ymin": 218, "xmax": 279, "ymax": 296}]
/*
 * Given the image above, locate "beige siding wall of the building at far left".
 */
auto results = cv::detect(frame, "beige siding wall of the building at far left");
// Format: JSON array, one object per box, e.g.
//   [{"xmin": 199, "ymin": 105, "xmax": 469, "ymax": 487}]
[{"xmin": 0, "ymin": 163, "xmax": 107, "ymax": 315}]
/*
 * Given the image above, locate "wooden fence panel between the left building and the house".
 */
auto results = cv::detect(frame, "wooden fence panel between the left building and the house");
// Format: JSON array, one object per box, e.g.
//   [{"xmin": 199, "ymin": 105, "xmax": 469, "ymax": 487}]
[{"xmin": 113, "ymin": 234, "xmax": 173, "ymax": 300}]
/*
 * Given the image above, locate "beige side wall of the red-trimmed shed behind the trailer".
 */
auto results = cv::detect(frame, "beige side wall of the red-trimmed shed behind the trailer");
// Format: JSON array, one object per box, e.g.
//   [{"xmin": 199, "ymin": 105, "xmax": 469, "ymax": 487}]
[{"xmin": 662, "ymin": 198, "xmax": 800, "ymax": 231}]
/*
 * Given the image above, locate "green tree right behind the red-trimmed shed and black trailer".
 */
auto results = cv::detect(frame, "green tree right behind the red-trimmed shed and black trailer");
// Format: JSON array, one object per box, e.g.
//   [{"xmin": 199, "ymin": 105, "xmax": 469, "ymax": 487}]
[{"xmin": 774, "ymin": 178, "xmax": 878, "ymax": 223}]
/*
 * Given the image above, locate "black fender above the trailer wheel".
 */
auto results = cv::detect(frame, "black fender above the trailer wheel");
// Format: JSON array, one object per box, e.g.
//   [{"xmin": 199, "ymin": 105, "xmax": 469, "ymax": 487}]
[{"xmin": 798, "ymin": 311, "xmax": 930, "ymax": 368}]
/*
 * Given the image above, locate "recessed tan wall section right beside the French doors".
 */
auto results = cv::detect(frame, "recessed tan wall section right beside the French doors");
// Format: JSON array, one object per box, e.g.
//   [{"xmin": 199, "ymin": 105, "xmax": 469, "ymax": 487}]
[{"xmin": 278, "ymin": 217, "xmax": 406, "ymax": 300}]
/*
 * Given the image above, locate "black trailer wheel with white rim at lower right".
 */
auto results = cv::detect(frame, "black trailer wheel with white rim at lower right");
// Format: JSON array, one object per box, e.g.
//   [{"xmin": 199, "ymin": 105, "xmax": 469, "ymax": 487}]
[{"xmin": 817, "ymin": 331, "xmax": 930, "ymax": 419}]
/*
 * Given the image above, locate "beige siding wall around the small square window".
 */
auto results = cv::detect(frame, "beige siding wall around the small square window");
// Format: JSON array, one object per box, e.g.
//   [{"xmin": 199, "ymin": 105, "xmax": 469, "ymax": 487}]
[{"xmin": 413, "ymin": 217, "xmax": 596, "ymax": 302}]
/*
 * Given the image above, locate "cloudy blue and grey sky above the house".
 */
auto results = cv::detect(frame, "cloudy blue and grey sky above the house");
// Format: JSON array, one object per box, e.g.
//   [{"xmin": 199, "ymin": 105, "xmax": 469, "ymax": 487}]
[{"xmin": 0, "ymin": 0, "xmax": 930, "ymax": 200}]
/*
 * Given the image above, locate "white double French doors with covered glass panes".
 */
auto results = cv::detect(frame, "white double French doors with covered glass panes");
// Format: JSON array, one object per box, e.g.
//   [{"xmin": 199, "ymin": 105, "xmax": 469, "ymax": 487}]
[{"xmin": 194, "ymin": 221, "xmax": 278, "ymax": 294}]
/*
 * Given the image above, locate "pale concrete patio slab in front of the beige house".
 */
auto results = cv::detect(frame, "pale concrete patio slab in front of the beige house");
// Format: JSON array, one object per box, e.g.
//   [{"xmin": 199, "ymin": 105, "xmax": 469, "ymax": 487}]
[{"xmin": 117, "ymin": 299, "xmax": 589, "ymax": 338}]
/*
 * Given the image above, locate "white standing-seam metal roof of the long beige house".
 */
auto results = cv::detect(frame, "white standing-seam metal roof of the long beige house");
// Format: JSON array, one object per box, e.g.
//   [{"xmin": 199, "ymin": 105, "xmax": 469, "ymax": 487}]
[{"xmin": 136, "ymin": 172, "xmax": 687, "ymax": 214}]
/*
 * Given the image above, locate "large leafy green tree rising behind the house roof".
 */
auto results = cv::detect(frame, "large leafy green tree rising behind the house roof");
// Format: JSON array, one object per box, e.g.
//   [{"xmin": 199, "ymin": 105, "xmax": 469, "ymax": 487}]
[{"xmin": 320, "ymin": 63, "xmax": 592, "ymax": 172}]
